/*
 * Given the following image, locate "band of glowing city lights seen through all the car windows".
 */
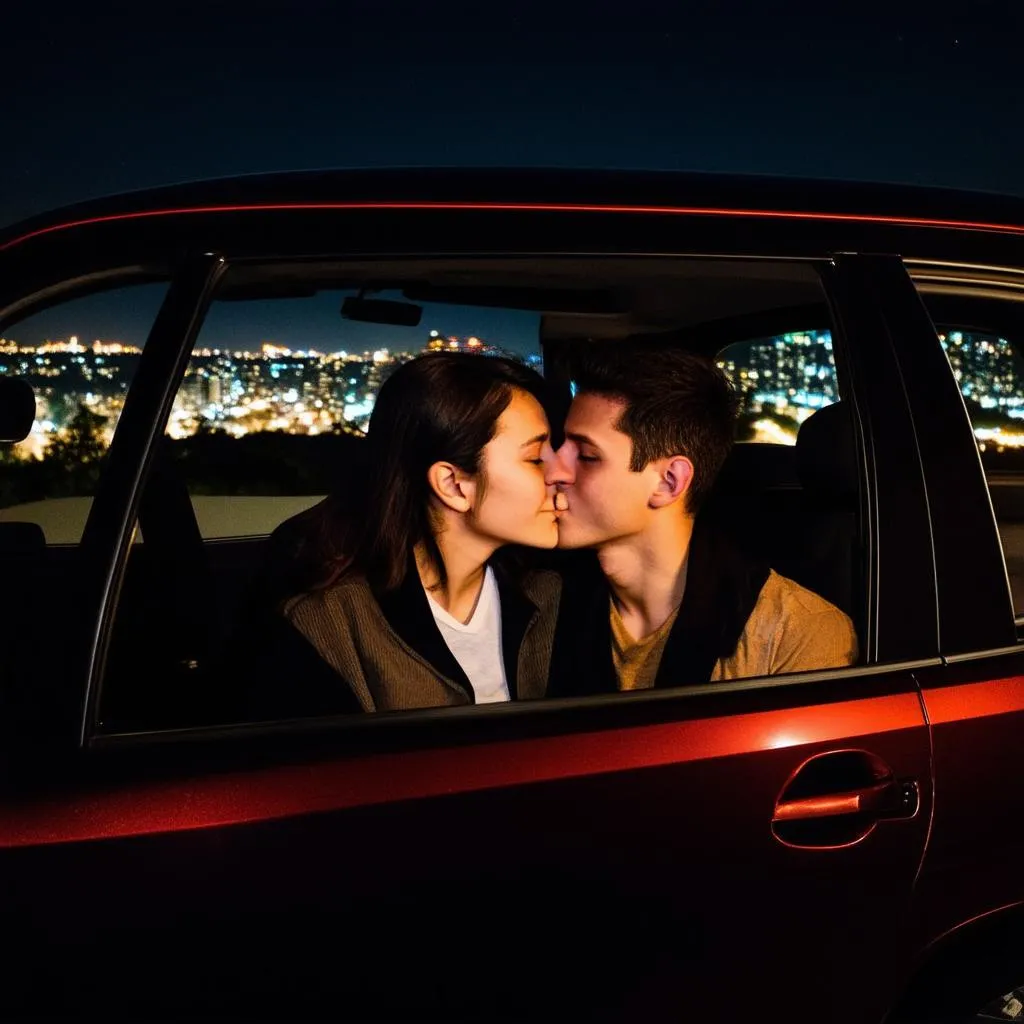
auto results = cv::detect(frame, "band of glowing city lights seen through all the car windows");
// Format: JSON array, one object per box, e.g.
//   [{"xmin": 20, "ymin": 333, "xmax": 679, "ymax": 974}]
[{"xmin": 8, "ymin": 329, "xmax": 1024, "ymax": 459}]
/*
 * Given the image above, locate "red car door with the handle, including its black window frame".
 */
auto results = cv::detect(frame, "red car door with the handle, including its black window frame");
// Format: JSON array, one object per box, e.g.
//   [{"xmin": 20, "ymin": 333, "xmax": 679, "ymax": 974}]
[{"xmin": 0, "ymin": 243, "xmax": 938, "ymax": 1020}]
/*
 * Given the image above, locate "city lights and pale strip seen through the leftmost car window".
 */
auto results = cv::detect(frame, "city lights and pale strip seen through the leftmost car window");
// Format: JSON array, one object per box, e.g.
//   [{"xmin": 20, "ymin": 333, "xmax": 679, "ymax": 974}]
[{"xmin": 0, "ymin": 285, "xmax": 166, "ymax": 546}]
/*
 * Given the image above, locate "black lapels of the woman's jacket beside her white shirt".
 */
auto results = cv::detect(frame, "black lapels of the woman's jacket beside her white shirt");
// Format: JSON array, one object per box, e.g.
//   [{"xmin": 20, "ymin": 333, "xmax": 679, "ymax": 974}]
[{"xmin": 373, "ymin": 553, "xmax": 537, "ymax": 700}]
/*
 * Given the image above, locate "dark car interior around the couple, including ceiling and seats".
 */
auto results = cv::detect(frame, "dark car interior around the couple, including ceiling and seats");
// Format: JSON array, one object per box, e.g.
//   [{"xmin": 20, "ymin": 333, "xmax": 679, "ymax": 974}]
[{"xmin": 0, "ymin": 257, "xmax": 865, "ymax": 732}]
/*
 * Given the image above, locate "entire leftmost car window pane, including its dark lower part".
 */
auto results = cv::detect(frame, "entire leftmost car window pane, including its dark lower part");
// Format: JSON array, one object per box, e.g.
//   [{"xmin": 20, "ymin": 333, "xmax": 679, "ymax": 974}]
[{"xmin": 0, "ymin": 285, "xmax": 166, "ymax": 720}]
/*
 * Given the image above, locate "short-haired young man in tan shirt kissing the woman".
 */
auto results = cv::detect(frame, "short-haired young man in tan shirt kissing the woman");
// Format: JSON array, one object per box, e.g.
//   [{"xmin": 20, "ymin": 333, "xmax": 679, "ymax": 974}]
[{"xmin": 548, "ymin": 347, "xmax": 857, "ymax": 696}]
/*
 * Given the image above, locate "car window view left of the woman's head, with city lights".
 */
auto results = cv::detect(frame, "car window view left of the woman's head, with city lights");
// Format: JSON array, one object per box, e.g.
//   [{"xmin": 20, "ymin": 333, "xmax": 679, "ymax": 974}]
[{"xmin": 159, "ymin": 290, "xmax": 542, "ymax": 540}]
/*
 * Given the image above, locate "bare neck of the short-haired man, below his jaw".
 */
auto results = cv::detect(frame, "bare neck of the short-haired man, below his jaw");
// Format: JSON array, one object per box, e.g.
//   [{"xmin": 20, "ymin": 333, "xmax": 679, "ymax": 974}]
[{"xmin": 597, "ymin": 516, "xmax": 693, "ymax": 640}]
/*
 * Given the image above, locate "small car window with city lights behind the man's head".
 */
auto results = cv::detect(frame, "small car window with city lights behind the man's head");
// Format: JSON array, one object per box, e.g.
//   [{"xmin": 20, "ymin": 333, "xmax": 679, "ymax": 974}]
[{"xmin": 717, "ymin": 330, "xmax": 839, "ymax": 444}]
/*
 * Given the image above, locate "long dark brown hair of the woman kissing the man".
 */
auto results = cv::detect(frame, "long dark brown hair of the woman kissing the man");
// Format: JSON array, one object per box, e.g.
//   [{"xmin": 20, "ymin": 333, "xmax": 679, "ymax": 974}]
[{"xmin": 293, "ymin": 352, "xmax": 548, "ymax": 593}]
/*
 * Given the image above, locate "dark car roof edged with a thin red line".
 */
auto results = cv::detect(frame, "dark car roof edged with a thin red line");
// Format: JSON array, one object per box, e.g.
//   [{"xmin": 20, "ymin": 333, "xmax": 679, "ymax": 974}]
[{"xmin": 0, "ymin": 168, "xmax": 1024, "ymax": 250}]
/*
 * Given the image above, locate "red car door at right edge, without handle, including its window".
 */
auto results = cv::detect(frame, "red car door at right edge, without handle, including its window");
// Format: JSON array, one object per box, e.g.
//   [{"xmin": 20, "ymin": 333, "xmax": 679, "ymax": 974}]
[{"xmin": 876, "ymin": 260, "xmax": 1024, "ymax": 1018}]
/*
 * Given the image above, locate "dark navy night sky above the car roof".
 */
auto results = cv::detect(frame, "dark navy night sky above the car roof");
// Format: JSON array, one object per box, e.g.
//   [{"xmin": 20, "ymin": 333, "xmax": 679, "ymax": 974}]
[{"xmin": 0, "ymin": 0, "xmax": 1024, "ymax": 347}]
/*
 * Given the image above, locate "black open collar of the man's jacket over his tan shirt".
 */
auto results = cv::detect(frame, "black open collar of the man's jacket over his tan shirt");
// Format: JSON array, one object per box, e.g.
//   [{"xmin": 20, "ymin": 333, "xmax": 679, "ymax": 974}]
[{"xmin": 548, "ymin": 516, "xmax": 768, "ymax": 696}]
